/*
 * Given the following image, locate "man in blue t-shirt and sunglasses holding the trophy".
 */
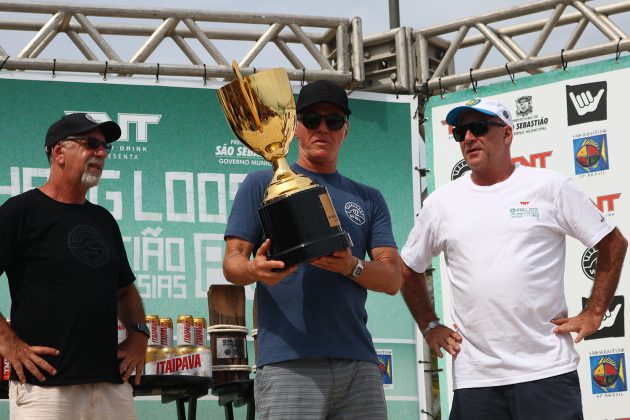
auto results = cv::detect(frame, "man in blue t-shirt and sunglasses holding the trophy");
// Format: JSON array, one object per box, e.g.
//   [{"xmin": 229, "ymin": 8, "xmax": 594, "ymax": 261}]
[{"xmin": 223, "ymin": 80, "xmax": 402, "ymax": 419}]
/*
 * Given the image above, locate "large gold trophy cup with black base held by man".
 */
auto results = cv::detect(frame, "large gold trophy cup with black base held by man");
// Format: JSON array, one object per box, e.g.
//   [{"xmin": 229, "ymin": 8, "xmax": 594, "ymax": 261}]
[{"xmin": 217, "ymin": 61, "xmax": 352, "ymax": 267}]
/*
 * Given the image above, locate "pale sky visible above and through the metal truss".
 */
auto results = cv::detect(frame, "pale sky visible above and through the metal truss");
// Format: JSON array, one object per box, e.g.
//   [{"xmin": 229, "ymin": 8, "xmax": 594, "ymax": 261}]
[{"xmin": 0, "ymin": 0, "xmax": 630, "ymax": 81}]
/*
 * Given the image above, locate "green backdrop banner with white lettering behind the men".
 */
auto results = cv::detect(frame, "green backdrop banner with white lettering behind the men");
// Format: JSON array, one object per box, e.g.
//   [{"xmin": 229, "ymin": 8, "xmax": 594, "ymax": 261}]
[{"xmin": 0, "ymin": 74, "xmax": 419, "ymax": 418}]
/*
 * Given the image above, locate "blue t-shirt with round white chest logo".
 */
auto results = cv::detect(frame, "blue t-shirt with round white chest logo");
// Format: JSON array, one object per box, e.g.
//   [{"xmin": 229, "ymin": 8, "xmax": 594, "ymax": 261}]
[{"xmin": 225, "ymin": 164, "xmax": 396, "ymax": 366}]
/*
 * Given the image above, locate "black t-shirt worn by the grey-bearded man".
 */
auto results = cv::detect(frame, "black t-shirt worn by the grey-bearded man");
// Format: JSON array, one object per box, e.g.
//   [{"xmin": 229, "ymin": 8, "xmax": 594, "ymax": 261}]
[{"xmin": 0, "ymin": 189, "xmax": 135, "ymax": 386}]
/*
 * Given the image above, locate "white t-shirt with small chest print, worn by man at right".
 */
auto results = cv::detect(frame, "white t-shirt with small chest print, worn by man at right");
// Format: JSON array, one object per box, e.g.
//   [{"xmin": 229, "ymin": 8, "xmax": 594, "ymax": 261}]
[{"xmin": 401, "ymin": 166, "xmax": 614, "ymax": 389}]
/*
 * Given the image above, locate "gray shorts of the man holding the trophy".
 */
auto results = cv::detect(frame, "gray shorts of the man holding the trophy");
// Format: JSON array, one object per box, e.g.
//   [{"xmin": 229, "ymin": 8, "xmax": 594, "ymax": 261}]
[{"xmin": 254, "ymin": 359, "xmax": 387, "ymax": 420}]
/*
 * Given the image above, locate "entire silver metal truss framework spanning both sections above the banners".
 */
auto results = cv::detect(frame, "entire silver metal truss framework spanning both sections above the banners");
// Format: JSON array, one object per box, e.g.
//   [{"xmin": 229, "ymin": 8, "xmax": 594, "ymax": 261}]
[{"xmin": 0, "ymin": 0, "xmax": 630, "ymax": 96}]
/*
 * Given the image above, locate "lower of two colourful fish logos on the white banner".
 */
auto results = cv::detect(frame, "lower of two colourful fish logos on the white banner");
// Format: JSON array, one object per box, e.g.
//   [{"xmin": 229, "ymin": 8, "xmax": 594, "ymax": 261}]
[{"xmin": 590, "ymin": 353, "xmax": 628, "ymax": 396}]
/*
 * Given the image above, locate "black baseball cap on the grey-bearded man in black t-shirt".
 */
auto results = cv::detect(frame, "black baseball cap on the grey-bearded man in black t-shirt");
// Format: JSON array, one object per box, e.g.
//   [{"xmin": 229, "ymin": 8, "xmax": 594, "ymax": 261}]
[{"xmin": 44, "ymin": 112, "xmax": 121, "ymax": 152}]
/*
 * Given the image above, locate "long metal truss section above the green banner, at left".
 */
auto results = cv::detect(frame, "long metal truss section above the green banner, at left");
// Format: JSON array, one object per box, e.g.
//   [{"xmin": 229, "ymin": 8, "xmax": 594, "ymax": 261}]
[{"xmin": 0, "ymin": 0, "xmax": 364, "ymax": 87}]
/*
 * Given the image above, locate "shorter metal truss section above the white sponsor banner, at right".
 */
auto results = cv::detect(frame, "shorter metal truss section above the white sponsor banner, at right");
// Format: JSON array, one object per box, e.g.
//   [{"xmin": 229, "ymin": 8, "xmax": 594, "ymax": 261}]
[{"xmin": 413, "ymin": 0, "xmax": 630, "ymax": 95}]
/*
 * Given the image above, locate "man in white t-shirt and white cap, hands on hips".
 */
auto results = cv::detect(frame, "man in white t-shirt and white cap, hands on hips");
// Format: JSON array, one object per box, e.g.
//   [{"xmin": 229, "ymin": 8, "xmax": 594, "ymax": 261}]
[{"xmin": 401, "ymin": 99, "xmax": 628, "ymax": 420}]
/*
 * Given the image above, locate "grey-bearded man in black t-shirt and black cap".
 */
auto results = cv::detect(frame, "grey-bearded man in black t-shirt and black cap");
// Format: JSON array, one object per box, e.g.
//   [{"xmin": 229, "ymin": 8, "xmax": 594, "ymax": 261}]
[{"xmin": 0, "ymin": 113, "xmax": 148, "ymax": 420}]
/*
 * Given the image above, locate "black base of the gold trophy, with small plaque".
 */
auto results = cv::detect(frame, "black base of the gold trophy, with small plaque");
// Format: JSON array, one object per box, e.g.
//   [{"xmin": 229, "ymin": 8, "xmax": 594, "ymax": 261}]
[{"xmin": 258, "ymin": 186, "xmax": 352, "ymax": 267}]
